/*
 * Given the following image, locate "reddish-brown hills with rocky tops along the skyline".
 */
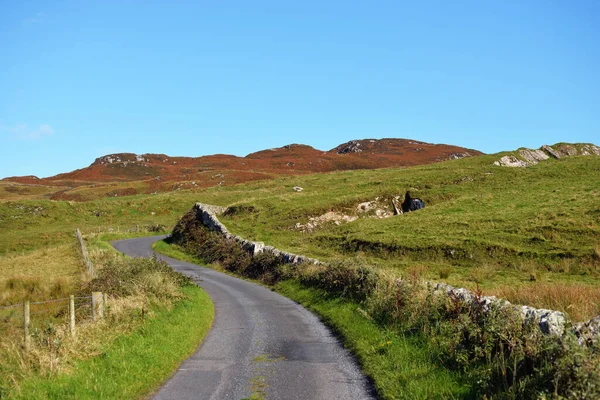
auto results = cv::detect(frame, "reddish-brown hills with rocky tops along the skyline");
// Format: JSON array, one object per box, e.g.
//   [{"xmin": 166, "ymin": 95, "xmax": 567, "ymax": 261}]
[{"xmin": 2, "ymin": 139, "xmax": 483, "ymax": 201}]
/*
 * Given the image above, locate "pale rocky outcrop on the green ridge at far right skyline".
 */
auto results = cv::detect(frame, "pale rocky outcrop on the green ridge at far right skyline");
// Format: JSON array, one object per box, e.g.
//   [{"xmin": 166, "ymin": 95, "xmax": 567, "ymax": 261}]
[{"xmin": 494, "ymin": 143, "xmax": 600, "ymax": 168}]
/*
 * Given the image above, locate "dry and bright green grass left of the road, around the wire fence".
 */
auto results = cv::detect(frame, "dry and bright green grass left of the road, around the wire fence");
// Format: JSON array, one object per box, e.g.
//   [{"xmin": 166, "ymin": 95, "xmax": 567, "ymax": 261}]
[{"xmin": 0, "ymin": 232, "xmax": 214, "ymax": 398}]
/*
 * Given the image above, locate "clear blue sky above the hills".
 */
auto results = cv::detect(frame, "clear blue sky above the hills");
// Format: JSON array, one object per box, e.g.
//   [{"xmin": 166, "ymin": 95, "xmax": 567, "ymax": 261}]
[{"xmin": 0, "ymin": 0, "xmax": 600, "ymax": 178}]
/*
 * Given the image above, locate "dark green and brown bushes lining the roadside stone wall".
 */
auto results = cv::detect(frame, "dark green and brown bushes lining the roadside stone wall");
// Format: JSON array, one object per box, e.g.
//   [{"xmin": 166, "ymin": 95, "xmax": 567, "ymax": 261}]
[{"xmin": 170, "ymin": 210, "xmax": 600, "ymax": 399}]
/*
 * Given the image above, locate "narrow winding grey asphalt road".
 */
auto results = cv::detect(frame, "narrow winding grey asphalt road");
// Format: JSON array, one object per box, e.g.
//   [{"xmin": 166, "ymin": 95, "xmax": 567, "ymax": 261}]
[{"xmin": 113, "ymin": 236, "xmax": 376, "ymax": 400}]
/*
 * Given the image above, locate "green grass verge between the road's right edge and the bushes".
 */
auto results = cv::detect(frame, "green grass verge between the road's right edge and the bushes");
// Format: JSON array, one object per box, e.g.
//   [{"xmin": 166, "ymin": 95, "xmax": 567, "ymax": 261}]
[{"xmin": 153, "ymin": 240, "xmax": 472, "ymax": 399}]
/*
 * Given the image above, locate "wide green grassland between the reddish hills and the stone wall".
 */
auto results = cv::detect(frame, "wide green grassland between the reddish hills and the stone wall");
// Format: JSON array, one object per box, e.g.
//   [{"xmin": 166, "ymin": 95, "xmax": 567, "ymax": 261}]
[{"xmin": 0, "ymin": 149, "xmax": 600, "ymax": 320}]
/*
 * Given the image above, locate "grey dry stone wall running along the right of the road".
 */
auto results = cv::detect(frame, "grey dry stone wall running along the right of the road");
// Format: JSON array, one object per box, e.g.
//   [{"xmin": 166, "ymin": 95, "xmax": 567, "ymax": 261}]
[{"xmin": 194, "ymin": 203, "xmax": 600, "ymax": 345}]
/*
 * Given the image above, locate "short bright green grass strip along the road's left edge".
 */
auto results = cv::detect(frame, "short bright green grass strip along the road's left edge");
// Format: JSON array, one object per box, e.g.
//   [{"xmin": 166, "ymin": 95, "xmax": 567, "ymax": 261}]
[{"xmin": 6, "ymin": 285, "xmax": 214, "ymax": 399}]
